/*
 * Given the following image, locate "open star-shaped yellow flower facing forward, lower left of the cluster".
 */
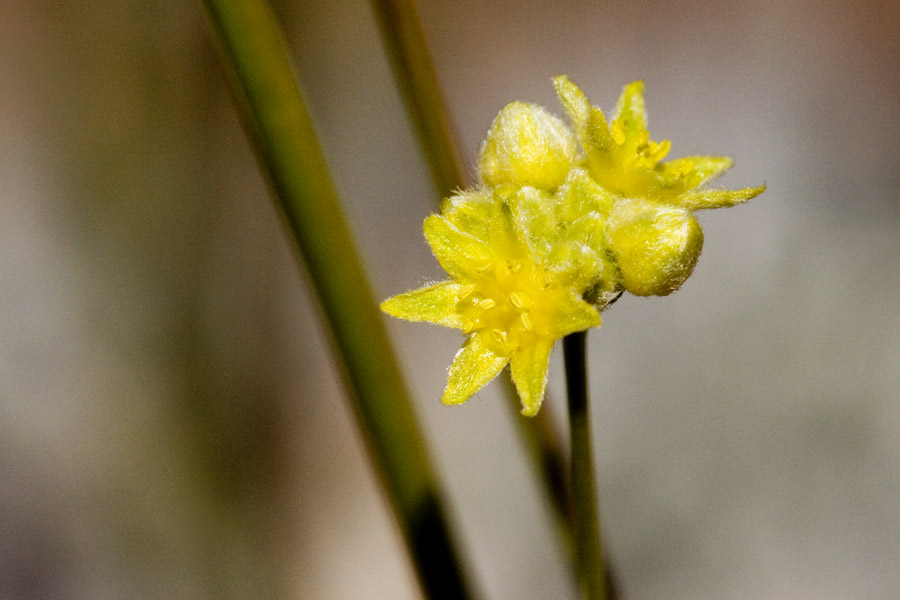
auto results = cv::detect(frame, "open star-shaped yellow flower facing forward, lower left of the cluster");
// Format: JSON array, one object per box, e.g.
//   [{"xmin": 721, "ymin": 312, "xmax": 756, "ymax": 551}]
[{"xmin": 381, "ymin": 186, "xmax": 600, "ymax": 416}]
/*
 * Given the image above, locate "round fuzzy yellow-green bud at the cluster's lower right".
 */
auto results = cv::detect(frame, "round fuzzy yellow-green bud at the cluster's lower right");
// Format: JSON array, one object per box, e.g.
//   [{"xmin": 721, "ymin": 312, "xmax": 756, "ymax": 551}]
[{"xmin": 606, "ymin": 199, "xmax": 703, "ymax": 296}]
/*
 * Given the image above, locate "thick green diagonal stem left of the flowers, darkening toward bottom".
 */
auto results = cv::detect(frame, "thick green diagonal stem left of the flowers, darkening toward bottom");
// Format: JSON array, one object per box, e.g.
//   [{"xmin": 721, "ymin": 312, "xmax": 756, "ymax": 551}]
[{"xmin": 200, "ymin": 0, "xmax": 471, "ymax": 598}]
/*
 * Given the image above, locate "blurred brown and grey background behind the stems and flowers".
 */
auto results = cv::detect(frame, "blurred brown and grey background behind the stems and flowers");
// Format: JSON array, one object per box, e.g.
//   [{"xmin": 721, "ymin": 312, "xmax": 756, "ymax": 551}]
[{"xmin": 0, "ymin": 0, "xmax": 900, "ymax": 600}]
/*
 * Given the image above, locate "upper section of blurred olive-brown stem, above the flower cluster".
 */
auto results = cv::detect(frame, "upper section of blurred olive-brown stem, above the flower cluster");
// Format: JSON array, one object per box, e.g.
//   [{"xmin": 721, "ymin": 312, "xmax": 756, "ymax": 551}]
[{"xmin": 372, "ymin": 0, "xmax": 465, "ymax": 193}]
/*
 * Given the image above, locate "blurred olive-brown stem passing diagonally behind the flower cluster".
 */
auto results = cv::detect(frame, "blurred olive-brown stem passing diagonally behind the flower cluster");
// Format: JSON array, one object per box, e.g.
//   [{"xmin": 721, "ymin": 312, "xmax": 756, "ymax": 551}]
[{"xmin": 372, "ymin": 0, "xmax": 574, "ymax": 564}]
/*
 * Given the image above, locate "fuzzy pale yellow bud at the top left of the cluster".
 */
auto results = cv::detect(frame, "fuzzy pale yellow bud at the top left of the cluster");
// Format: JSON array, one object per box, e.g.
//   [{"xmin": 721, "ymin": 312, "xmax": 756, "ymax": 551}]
[{"xmin": 478, "ymin": 102, "xmax": 578, "ymax": 189}]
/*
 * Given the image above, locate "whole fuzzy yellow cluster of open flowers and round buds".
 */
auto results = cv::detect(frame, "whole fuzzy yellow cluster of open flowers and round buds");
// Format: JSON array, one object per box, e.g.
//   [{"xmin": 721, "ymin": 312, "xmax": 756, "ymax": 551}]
[{"xmin": 381, "ymin": 76, "xmax": 764, "ymax": 416}]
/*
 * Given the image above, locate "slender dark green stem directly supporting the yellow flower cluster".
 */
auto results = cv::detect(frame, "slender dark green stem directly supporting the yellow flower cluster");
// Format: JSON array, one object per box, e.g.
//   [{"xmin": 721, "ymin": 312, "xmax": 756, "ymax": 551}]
[{"xmin": 563, "ymin": 331, "xmax": 608, "ymax": 600}]
